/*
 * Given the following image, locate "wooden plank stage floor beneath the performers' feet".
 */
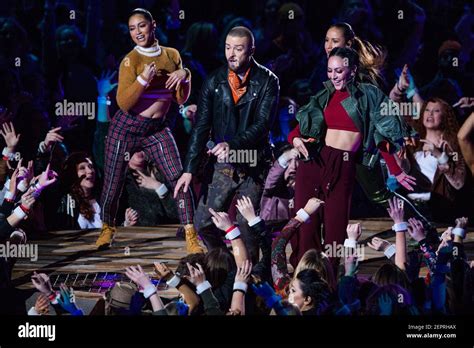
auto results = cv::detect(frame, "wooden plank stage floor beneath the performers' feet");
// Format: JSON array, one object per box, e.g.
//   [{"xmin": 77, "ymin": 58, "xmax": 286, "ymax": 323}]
[{"xmin": 12, "ymin": 218, "xmax": 474, "ymax": 296}]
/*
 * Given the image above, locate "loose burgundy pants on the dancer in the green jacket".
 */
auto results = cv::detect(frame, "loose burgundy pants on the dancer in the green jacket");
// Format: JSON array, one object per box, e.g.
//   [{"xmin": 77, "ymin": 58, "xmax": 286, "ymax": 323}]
[{"xmin": 290, "ymin": 146, "xmax": 356, "ymax": 268}]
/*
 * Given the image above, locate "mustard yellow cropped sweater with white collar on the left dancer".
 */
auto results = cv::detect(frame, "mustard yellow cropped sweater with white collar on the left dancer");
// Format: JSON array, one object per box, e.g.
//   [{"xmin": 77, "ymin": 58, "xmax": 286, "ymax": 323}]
[{"xmin": 117, "ymin": 45, "xmax": 191, "ymax": 111}]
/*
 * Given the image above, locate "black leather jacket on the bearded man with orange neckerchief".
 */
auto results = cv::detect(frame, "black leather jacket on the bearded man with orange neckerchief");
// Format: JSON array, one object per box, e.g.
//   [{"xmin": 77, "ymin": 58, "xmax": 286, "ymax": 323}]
[{"xmin": 183, "ymin": 58, "xmax": 280, "ymax": 174}]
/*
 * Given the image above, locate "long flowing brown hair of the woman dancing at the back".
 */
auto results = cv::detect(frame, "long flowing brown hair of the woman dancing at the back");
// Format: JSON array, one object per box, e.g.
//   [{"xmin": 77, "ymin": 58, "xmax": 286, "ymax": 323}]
[{"xmin": 329, "ymin": 22, "xmax": 387, "ymax": 85}]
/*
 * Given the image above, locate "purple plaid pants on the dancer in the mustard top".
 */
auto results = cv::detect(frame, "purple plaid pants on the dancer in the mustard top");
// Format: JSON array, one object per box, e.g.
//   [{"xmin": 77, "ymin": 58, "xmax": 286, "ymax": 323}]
[{"xmin": 101, "ymin": 110, "xmax": 194, "ymax": 226}]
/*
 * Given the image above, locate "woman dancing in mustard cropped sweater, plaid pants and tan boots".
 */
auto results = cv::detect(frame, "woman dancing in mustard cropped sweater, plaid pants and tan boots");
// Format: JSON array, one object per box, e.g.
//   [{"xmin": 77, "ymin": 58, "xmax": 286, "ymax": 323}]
[{"xmin": 96, "ymin": 9, "xmax": 203, "ymax": 253}]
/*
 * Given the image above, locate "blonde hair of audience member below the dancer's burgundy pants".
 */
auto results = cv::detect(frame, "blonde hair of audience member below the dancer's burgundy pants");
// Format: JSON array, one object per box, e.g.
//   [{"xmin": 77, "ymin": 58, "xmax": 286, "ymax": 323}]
[{"xmin": 293, "ymin": 249, "xmax": 336, "ymax": 290}]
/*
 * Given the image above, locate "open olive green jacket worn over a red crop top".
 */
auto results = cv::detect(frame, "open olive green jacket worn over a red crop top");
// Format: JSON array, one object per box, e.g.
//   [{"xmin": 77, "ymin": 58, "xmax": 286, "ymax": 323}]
[{"xmin": 296, "ymin": 80, "xmax": 416, "ymax": 168}]
